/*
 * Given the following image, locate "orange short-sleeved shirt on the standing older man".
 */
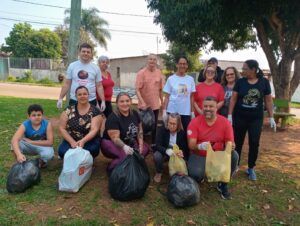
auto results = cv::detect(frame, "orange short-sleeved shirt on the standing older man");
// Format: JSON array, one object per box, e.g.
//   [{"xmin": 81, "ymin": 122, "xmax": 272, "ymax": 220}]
[{"xmin": 135, "ymin": 68, "xmax": 165, "ymax": 110}]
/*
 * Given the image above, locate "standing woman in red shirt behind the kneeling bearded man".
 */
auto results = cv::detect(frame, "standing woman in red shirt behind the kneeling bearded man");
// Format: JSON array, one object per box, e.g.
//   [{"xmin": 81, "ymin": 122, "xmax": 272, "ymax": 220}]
[{"xmin": 194, "ymin": 65, "xmax": 224, "ymax": 116}]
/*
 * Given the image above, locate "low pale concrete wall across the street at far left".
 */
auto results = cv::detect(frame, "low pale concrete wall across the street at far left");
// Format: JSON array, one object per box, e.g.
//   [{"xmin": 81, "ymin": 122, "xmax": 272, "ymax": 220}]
[{"xmin": 9, "ymin": 68, "xmax": 65, "ymax": 82}]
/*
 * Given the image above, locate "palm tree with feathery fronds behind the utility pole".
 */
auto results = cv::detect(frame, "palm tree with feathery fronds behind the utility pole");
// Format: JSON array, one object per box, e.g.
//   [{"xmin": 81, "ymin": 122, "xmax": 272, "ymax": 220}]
[{"xmin": 64, "ymin": 7, "xmax": 110, "ymax": 48}]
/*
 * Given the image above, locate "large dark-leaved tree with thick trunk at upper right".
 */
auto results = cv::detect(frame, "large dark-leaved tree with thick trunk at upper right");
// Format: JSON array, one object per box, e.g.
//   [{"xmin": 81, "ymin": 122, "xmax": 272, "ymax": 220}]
[{"xmin": 146, "ymin": 0, "xmax": 300, "ymax": 100}]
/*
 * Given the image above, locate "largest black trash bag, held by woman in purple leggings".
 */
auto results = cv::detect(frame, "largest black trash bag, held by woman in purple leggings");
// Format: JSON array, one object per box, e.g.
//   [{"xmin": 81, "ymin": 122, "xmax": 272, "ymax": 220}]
[{"xmin": 109, "ymin": 151, "xmax": 150, "ymax": 201}]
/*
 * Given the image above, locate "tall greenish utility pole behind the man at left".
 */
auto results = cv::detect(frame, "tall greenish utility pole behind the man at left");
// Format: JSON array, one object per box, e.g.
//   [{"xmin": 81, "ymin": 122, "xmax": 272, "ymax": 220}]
[{"xmin": 67, "ymin": 0, "xmax": 81, "ymax": 103}]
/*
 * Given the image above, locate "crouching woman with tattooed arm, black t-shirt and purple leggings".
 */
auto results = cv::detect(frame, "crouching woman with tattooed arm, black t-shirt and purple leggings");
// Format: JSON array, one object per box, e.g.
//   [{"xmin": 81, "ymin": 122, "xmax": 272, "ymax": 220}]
[{"xmin": 101, "ymin": 92, "xmax": 149, "ymax": 172}]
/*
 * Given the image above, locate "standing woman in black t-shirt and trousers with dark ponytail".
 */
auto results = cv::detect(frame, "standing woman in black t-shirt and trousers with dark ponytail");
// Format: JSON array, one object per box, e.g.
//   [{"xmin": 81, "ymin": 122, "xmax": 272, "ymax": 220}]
[{"xmin": 228, "ymin": 60, "xmax": 276, "ymax": 180}]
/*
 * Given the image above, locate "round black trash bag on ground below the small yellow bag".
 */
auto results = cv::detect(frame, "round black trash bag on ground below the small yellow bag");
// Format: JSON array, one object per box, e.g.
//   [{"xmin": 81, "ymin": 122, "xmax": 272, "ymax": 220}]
[{"xmin": 167, "ymin": 174, "xmax": 200, "ymax": 207}]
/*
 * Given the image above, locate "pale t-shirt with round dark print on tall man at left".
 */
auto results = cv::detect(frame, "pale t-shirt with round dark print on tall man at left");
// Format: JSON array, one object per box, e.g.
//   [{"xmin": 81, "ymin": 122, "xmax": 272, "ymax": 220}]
[{"xmin": 67, "ymin": 60, "xmax": 102, "ymax": 101}]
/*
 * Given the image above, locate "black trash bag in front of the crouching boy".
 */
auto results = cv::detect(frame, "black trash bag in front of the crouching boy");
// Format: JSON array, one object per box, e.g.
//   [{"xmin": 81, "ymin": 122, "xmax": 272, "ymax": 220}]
[{"xmin": 6, "ymin": 159, "xmax": 41, "ymax": 193}]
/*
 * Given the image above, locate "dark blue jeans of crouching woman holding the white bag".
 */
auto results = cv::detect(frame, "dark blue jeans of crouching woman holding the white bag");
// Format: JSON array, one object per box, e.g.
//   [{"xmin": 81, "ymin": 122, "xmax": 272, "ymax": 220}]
[{"xmin": 58, "ymin": 137, "xmax": 100, "ymax": 158}]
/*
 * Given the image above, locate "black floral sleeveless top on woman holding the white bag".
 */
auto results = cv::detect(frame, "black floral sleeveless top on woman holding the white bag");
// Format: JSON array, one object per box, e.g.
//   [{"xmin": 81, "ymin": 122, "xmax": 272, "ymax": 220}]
[{"xmin": 65, "ymin": 104, "xmax": 100, "ymax": 141}]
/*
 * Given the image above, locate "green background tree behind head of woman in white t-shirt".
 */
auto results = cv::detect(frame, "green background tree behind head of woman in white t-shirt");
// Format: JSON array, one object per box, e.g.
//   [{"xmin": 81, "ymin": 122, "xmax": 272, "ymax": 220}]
[{"xmin": 161, "ymin": 43, "xmax": 202, "ymax": 72}]
